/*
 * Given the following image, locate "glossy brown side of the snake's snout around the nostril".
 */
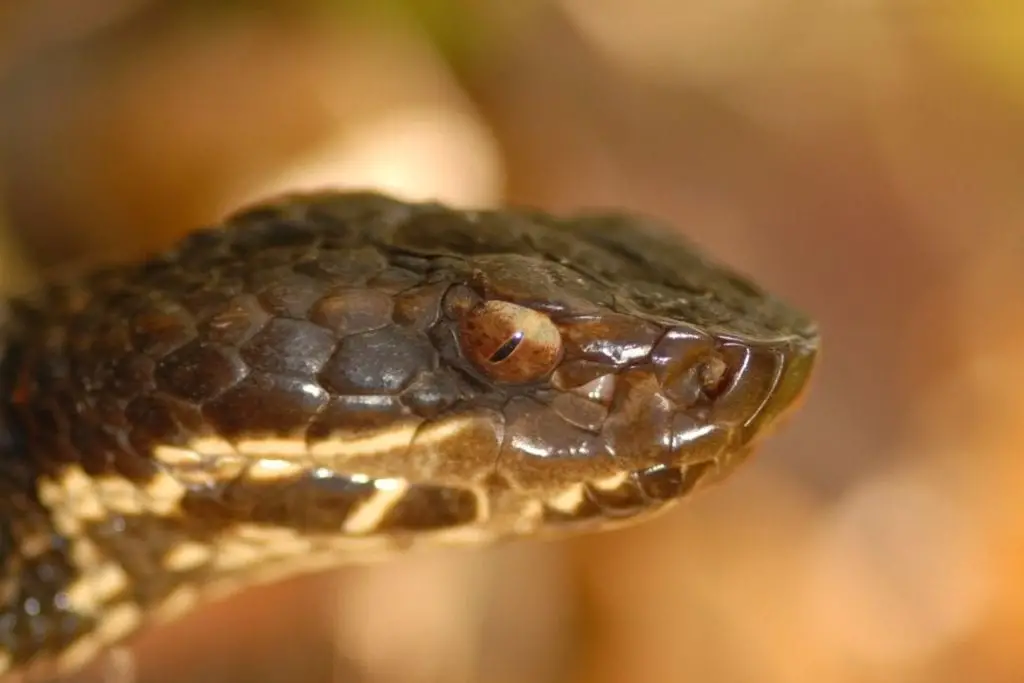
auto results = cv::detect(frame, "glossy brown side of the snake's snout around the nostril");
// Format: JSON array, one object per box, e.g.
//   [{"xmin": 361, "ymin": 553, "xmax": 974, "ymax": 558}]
[{"xmin": 602, "ymin": 327, "xmax": 814, "ymax": 483}]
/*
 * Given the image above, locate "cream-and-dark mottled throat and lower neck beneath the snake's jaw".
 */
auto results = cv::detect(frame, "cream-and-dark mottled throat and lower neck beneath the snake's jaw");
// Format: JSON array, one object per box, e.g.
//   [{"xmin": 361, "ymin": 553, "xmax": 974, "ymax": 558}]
[{"xmin": 0, "ymin": 440, "xmax": 428, "ymax": 675}]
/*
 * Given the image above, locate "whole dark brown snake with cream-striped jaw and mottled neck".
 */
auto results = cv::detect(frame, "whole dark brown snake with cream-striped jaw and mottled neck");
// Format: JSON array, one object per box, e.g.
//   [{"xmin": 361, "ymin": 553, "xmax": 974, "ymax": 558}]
[{"xmin": 0, "ymin": 189, "xmax": 819, "ymax": 676}]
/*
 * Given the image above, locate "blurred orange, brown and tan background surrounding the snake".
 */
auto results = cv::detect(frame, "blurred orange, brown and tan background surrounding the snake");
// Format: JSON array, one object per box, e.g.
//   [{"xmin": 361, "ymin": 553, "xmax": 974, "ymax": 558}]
[{"xmin": 0, "ymin": 0, "xmax": 1024, "ymax": 683}]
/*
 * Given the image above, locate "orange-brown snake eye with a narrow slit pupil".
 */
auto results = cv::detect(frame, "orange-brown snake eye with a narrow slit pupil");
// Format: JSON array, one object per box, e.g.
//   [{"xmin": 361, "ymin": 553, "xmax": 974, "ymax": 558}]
[{"xmin": 459, "ymin": 301, "xmax": 562, "ymax": 384}]
